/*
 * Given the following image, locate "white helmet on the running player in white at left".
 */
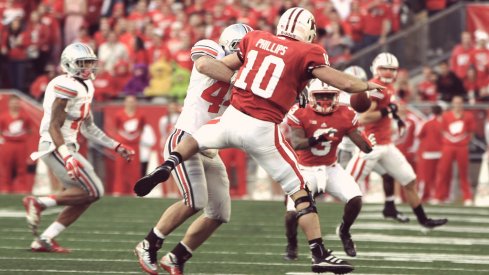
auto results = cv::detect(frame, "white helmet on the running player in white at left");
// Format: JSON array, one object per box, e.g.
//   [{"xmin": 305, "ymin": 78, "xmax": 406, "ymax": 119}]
[{"xmin": 61, "ymin": 42, "xmax": 98, "ymax": 80}]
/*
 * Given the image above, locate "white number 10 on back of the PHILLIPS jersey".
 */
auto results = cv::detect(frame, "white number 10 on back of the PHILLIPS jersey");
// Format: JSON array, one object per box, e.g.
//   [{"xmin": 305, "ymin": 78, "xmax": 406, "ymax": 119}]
[{"xmin": 234, "ymin": 50, "xmax": 285, "ymax": 98}]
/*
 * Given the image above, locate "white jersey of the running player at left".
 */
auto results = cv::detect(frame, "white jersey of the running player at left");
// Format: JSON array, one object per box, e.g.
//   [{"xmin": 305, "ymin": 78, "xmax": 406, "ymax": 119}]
[{"xmin": 39, "ymin": 74, "xmax": 94, "ymax": 143}]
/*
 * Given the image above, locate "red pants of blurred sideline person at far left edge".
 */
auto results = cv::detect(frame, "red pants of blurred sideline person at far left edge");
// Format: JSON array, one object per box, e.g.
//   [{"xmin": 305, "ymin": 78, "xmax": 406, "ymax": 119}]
[{"xmin": 0, "ymin": 141, "xmax": 31, "ymax": 193}]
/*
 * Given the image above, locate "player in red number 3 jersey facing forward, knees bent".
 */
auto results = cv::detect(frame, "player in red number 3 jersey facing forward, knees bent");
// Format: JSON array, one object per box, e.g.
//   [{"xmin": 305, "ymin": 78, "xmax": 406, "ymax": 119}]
[{"xmin": 284, "ymin": 79, "xmax": 375, "ymax": 260}]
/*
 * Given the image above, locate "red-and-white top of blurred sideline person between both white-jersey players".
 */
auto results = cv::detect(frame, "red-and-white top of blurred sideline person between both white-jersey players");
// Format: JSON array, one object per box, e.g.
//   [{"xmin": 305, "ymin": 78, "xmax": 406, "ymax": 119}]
[{"xmin": 115, "ymin": 110, "xmax": 146, "ymax": 144}]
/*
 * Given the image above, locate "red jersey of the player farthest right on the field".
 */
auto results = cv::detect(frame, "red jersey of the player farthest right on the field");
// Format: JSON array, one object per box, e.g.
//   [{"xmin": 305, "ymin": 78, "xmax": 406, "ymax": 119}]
[{"xmin": 365, "ymin": 78, "xmax": 395, "ymax": 144}]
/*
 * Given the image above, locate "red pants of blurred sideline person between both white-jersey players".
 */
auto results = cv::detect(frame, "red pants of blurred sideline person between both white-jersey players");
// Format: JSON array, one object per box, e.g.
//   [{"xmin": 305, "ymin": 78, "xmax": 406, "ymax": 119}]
[{"xmin": 112, "ymin": 147, "xmax": 141, "ymax": 195}]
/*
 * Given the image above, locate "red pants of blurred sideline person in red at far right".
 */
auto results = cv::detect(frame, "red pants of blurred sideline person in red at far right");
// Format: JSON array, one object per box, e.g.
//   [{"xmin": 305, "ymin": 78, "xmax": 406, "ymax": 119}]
[{"xmin": 435, "ymin": 146, "xmax": 472, "ymax": 200}]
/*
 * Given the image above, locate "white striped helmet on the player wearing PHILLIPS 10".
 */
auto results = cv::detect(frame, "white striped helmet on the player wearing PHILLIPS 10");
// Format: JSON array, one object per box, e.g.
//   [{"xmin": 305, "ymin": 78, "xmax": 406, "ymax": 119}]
[{"xmin": 277, "ymin": 8, "xmax": 316, "ymax": 43}]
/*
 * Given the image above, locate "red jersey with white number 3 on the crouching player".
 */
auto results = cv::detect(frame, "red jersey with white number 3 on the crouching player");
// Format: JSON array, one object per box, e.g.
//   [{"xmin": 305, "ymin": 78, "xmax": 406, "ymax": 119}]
[{"xmin": 287, "ymin": 105, "xmax": 358, "ymax": 166}]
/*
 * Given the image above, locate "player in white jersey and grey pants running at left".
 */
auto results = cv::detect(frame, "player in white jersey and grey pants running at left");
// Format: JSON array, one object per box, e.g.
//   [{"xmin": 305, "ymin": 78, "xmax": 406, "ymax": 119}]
[{"xmin": 22, "ymin": 43, "xmax": 134, "ymax": 252}]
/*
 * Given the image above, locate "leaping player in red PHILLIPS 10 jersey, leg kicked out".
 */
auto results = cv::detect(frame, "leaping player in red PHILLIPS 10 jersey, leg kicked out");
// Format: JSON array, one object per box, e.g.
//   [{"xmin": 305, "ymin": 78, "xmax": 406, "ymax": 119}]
[{"xmin": 134, "ymin": 8, "xmax": 383, "ymax": 273}]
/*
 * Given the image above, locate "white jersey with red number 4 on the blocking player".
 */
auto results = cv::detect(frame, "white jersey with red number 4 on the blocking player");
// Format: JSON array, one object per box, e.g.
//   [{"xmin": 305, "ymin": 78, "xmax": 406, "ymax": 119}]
[{"xmin": 175, "ymin": 39, "xmax": 231, "ymax": 134}]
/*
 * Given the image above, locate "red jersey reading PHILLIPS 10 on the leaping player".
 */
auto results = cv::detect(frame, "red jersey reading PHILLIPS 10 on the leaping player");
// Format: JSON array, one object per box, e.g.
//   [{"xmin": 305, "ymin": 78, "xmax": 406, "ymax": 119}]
[{"xmin": 231, "ymin": 31, "xmax": 329, "ymax": 124}]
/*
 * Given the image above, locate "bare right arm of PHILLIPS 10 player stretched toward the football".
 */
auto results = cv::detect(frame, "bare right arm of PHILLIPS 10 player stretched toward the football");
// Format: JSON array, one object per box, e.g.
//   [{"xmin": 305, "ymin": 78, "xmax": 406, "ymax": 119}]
[{"xmin": 312, "ymin": 66, "xmax": 385, "ymax": 93}]
